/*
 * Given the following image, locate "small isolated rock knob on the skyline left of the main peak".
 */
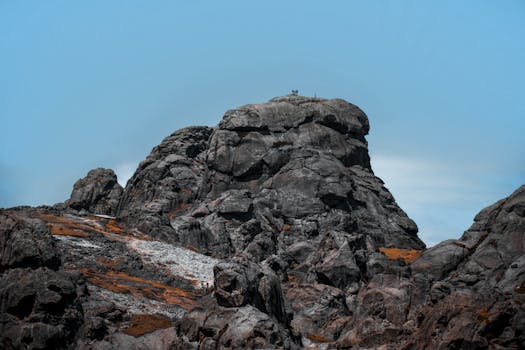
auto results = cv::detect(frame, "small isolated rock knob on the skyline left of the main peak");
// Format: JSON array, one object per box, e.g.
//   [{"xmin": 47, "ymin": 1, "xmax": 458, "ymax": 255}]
[{"xmin": 66, "ymin": 168, "xmax": 122, "ymax": 215}]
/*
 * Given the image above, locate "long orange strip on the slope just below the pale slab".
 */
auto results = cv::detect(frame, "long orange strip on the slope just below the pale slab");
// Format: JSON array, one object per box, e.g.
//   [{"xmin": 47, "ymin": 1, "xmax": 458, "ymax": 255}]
[{"xmin": 80, "ymin": 268, "xmax": 197, "ymax": 310}]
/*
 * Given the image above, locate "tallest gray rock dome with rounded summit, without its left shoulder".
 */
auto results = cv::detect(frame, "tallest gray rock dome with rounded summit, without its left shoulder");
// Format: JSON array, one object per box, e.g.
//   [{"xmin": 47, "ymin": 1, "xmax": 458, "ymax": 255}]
[{"xmin": 201, "ymin": 96, "xmax": 424, "ymax": 250}]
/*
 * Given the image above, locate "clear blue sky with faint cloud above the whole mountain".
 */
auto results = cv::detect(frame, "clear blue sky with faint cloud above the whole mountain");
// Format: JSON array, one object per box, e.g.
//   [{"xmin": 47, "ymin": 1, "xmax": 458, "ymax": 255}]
[{"xmin": 0, "ymin": 0, "xmax": 525, "ymax": 245}]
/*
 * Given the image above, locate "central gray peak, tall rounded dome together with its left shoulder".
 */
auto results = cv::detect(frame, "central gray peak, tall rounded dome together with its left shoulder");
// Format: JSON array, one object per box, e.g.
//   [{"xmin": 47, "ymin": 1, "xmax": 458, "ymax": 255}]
[{"xmin": 113, "ymin": 96, "xmax": 424, "ymax": 254}]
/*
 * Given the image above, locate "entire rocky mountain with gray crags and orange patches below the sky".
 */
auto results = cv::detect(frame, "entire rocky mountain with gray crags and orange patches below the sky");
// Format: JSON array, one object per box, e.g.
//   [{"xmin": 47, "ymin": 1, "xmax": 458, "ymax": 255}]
[{"xmin": 0, "ymin": 96, "xmax": 525, "ymax": 349}]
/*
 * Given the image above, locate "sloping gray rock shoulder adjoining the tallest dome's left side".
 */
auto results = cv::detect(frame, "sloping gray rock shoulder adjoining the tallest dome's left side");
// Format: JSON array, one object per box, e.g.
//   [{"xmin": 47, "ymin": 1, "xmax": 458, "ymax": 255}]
[{"xmin": 118, "ymin": 127, "xmax": 211, "ymax": 241}]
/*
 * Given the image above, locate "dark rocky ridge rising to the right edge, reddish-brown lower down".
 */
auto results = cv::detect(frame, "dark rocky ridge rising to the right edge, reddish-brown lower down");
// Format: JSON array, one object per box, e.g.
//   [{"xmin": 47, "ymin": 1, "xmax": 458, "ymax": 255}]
[{"xmin": 407, "ymin": 186, "xmax": 525, "ymax": 349}]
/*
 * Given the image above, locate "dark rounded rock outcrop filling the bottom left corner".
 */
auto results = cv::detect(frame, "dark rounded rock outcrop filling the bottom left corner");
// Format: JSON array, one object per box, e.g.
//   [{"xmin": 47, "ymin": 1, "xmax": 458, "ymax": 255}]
[{"xmin": 0, "ymin": 212, "xmax": 85, "ymax": 349}]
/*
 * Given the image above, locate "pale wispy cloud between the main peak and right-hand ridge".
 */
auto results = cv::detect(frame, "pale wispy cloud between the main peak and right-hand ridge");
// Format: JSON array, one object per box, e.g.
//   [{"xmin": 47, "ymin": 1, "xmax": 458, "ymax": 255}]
[{"xmin": 372, "ymin": 154, "xmax": 494, "ymax": 246}]
